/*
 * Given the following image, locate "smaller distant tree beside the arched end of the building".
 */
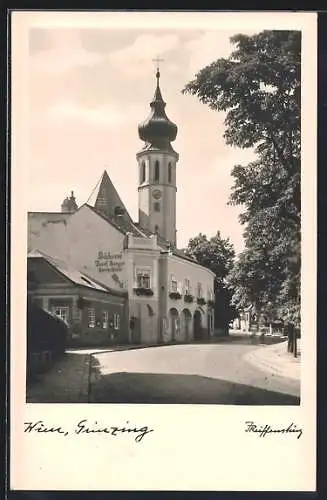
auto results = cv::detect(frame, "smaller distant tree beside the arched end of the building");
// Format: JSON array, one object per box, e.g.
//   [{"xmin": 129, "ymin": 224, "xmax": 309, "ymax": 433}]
[{"xmin": 186, "ymin": 231, "xmax": 237, "ymax": 329}]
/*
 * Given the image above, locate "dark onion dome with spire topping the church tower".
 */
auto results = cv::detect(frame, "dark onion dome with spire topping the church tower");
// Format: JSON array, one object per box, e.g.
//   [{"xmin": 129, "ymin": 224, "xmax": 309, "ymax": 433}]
[{"xmin": 138, "ymin": 70, "xmax": 177, "ymax": 150}]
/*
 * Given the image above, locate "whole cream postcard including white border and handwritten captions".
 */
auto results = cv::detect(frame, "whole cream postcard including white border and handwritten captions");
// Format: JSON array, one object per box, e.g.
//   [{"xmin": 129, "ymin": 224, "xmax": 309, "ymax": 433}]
[{"xmin": 11, "ymin": 11, "xmax": 316, "ymax": 491}]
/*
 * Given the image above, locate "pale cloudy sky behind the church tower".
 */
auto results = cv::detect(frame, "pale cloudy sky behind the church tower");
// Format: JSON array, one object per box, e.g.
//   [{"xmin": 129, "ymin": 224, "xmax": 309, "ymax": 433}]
[{"xmin": 28, "ymin": 27, "xmax": 260, "ymax": 252}]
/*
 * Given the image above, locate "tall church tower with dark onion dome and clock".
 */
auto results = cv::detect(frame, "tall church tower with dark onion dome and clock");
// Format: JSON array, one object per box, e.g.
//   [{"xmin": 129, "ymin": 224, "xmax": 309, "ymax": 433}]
[{"xmin": 136, "ymin": 64, "xmax": 178, "ymax": 246}]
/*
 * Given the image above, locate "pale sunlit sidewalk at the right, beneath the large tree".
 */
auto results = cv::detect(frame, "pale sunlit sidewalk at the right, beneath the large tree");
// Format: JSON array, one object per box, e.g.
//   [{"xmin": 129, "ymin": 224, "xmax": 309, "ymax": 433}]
[{"xmin": 245, "ymin": 340, "xmax": 301, "ymax": 380}]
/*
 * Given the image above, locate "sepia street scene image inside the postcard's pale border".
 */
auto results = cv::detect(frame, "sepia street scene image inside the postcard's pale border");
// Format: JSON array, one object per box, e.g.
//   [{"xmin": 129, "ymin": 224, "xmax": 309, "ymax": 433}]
[{"xmin": 27, "ymin": 19, "xmax": 301, "ymax": 405}]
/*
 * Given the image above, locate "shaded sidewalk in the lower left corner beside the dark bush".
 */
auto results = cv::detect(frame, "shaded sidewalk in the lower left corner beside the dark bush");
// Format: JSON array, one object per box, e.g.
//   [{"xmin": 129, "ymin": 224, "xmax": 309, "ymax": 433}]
[{"xmin": 26, "ymin": 353, "xmax": 90, "ymax": 403}]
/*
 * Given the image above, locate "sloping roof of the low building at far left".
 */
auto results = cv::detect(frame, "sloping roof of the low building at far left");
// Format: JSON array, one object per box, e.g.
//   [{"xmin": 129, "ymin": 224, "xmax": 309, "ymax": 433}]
[{"xmin": 27, "ymin": 249, "xmax": 126, "ymax": 295}]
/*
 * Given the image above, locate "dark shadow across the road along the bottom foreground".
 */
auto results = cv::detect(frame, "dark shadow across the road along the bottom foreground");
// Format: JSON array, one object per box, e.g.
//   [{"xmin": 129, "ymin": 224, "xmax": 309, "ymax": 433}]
[{"xmin": 90, "ymin": 372, "xmax": 300, "ymax": 405}]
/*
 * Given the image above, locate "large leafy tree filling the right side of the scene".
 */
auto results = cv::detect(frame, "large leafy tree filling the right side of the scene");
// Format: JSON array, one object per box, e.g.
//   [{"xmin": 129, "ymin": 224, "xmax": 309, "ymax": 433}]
[{"xmin": 183, "ymin": 30, "xmax": 301, "ymax": 323}]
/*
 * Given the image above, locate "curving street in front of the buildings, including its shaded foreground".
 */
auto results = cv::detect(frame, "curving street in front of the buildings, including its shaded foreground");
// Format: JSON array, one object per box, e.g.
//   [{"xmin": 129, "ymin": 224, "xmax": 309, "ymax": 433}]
[{"xmin": 90, "ymin": 339, "xmax": 300, "ymax": 405}]
